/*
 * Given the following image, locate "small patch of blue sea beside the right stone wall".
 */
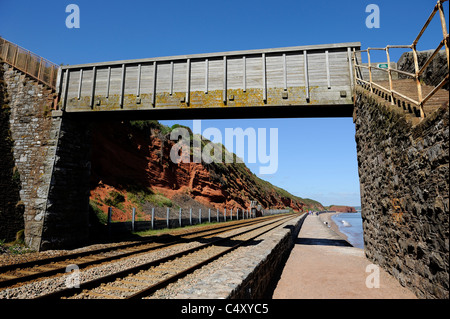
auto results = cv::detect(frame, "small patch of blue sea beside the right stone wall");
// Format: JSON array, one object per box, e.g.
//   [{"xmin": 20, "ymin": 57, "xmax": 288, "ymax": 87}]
[{"xmin": 331, "ymin": 213, "xmax": 364, "ymax": 249}]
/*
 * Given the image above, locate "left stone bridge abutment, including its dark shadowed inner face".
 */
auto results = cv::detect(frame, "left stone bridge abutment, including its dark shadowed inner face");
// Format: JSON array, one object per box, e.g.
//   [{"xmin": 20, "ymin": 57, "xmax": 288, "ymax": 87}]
[{"xmin": 0, "ymin": 64, "xmax": 91, "ymax": 250}]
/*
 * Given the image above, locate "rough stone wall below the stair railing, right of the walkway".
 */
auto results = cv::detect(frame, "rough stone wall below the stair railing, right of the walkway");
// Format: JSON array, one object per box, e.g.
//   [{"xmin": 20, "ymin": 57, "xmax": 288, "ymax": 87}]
[{"xmin": 354, "ymin": 90, "xmax": 449, "ymax": 298}]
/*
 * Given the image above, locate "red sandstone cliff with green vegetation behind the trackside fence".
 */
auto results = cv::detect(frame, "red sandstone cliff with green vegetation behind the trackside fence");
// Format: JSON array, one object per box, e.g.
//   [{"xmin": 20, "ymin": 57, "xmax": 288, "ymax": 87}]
[{"xmin": 91, "ymin": 121, "xmax": 323, "ymax": 220}]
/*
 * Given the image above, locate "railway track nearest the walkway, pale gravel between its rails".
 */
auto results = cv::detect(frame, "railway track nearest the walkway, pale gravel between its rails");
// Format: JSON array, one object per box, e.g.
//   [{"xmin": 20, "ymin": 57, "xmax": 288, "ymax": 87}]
[{"xmin": 32, "ymin": 215, "xmax": 295, "ymax": 299}]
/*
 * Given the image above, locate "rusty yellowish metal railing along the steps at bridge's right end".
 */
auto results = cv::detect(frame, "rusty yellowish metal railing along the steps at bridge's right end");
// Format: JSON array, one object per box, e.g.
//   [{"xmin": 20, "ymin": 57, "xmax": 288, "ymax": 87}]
[{"xmin": 353, "ymin": 0, "xmax": 449, "ymax": 118}]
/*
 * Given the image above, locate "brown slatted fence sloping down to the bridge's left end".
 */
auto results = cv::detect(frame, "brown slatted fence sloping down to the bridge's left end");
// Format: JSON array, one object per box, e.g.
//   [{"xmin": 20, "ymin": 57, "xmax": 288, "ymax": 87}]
[{"xmin": 0, "ymin": 37, "xmax": 60, "ymax": 90}]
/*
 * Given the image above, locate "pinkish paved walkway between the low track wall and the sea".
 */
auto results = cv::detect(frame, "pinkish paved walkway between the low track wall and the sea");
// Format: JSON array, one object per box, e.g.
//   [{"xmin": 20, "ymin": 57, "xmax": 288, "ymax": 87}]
[{"xmin": 273, "ymin": 215, "xmax": 416, "ymax": 299}]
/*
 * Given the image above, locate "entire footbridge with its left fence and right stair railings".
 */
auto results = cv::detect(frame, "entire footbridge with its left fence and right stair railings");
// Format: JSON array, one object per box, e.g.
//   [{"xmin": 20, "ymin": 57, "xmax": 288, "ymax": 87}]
[{"xmin": 0, "ymin": 0, "xmax": 449, "ymax": 119}]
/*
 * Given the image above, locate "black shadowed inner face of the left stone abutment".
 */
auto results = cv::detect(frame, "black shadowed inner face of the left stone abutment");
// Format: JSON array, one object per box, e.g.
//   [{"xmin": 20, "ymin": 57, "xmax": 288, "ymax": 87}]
[{"xmin": 35, "ymin": 113, "xmax": 91, "ymax": 250}]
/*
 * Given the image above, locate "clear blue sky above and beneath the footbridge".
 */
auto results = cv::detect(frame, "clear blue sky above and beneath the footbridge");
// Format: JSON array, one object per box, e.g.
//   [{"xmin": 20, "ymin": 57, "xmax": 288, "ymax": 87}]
[{"xmin": 0, "ymin": 0, "xmax": 448, "ymax": 205}]
